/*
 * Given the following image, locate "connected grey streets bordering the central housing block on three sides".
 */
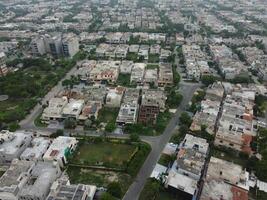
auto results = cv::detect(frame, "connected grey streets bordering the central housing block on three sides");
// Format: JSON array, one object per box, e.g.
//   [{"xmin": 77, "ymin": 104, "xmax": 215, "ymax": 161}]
[{"xmin": 16, "ymin": 55, "xmax": 200, "ymax": 200}]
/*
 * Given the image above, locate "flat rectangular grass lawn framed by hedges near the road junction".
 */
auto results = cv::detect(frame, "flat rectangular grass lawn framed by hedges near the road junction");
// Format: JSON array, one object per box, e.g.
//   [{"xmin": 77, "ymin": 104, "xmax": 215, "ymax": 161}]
[{"xmin": 71, "ymin": 142, "xmax": 136, "ymax": 168}]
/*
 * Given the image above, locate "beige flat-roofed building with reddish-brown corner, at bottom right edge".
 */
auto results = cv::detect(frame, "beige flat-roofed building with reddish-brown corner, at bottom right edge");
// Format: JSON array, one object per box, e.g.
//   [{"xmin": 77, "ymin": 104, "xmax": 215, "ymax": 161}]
[{"xmin": 200, "ymin": 157, "xmax": 249, "ymax": 200}]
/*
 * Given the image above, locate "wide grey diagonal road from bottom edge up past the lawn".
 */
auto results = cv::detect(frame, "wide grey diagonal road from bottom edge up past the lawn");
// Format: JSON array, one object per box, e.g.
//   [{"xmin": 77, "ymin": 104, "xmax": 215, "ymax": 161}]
[{"xmin": 123, "ymin": 83, "xmax": 200, "ymax": 200}]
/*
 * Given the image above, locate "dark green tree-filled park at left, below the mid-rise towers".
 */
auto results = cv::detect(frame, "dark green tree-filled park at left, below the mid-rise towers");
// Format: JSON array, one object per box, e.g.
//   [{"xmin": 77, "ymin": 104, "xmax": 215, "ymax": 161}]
[{"xmin": 0, "ymin": 58, "xmax": 76, "ymax": 123}]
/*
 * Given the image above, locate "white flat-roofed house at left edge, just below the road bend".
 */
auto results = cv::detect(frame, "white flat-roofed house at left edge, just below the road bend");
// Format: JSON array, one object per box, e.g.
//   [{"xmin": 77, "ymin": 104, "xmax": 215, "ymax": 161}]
[{"xmin": 0, "ymin": 130, "xmax": 33, "ymax": 164}]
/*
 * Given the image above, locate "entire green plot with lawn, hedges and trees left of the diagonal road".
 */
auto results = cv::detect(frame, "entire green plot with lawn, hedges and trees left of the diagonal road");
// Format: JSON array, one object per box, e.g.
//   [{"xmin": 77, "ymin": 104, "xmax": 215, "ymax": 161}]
[{"xmin": 67, "ymin": 137, "xmax": 151, "ymax": 198}]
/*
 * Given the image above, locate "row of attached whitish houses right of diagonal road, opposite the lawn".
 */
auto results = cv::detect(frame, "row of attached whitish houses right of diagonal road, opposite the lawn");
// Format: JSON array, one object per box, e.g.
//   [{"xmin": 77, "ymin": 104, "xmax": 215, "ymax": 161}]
[{"xmin": 165, "ymin": 134, "xmax": 209, "ymax": 199}]
